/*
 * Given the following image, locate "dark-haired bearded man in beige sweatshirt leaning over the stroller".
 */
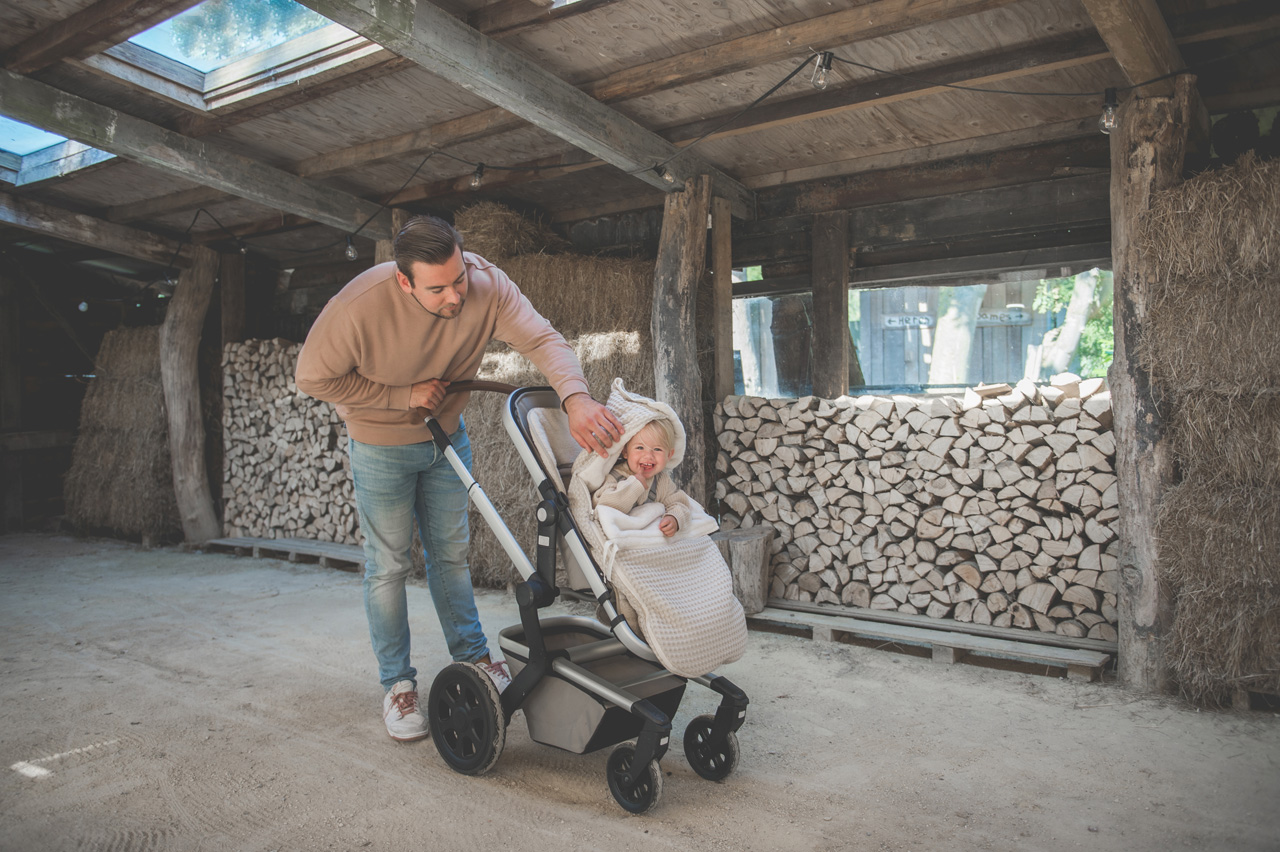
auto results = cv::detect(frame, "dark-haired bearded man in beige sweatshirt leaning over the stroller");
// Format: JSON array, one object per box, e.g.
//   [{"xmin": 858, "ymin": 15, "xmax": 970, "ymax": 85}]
[{"xmin": 296, "ymin": 216, "xmax": 622, "ymax": 741}]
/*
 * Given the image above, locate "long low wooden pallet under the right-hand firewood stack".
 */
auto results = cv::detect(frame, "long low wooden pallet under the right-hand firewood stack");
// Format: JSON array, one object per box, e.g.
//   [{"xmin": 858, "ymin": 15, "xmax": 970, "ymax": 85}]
[{"xmin": 748, "ymin": 606, "xmax": 1111, "ymax": 681}]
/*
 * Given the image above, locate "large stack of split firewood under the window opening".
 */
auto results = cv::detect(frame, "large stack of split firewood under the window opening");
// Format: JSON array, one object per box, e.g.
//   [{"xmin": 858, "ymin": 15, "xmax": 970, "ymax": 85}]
[{"xmin": 716, "ymin": 375, "xmax": 1119, "ymax": 641}]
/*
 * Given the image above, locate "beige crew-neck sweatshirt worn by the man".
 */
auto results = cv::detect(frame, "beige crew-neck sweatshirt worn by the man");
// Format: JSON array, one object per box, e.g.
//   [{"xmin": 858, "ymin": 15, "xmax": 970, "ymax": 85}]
[{"xmin": 296, "ymin": 252, "xmax": 589, "ymax": 446}]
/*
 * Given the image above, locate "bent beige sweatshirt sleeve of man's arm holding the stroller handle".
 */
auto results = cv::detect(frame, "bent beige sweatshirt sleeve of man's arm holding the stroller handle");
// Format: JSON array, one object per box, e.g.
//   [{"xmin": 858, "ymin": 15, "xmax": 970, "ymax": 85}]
[{"xmin": 294, "ymin": 302, "xmax": 412, "ymax": 411}]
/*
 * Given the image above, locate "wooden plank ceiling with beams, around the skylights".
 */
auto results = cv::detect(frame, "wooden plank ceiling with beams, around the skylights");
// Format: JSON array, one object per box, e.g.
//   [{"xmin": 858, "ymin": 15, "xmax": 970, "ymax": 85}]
[{"xmin": 0, "ymin": 0, "xmax": 1280, "ymax": 285}]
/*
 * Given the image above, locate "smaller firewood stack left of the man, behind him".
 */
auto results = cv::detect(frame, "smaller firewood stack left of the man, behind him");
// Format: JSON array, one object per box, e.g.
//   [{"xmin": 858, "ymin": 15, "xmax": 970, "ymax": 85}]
[{"xmin": 223, "ymin": 340, "xmax": 360, "ymax": 544}]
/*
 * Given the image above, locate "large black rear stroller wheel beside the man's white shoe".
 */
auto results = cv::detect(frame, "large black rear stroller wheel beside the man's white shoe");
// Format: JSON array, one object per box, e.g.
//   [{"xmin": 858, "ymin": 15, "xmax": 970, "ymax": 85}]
[{"xmin": 426, "ymin": 663, "xmax": 507, "ymax": 775}]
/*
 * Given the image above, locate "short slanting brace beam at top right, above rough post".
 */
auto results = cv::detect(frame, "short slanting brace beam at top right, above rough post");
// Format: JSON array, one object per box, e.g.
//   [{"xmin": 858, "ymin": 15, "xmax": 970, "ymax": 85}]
[{"xmin": 1083, "ymin": 0, "xmax": 1183, "ymax": 96}]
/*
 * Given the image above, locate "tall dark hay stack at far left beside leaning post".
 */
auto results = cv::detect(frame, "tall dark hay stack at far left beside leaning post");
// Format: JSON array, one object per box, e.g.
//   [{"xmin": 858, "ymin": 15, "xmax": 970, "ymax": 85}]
[{"xmin": 64, "ymin": 326, "xmax": 182, "ymax": 542}]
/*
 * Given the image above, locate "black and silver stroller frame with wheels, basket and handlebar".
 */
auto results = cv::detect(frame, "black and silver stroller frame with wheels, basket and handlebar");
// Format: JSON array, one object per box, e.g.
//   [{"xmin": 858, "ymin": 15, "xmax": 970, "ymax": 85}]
[{"xmin": 425, "ymin": 381, "xmax": 748, "ymax": 814}]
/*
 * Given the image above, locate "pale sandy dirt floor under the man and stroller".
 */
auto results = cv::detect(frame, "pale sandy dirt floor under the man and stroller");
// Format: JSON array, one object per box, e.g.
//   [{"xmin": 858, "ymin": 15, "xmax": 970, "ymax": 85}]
[{"xmin": 0, "ymin": 535, "xmax": 1280, "ymax": 852}]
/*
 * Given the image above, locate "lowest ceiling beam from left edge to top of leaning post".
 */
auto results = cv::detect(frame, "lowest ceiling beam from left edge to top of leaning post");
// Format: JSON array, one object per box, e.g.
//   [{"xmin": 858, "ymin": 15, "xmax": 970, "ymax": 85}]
[{"xmin": 0, "ymin": 192, "xmax": 191, "ymax": 266}]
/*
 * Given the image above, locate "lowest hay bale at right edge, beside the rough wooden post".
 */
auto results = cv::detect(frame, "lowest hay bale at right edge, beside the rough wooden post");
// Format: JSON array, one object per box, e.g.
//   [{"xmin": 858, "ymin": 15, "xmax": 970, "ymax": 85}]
[{"xmin": 1156, "ymin": 480, "xmax": 1280, "ymax": 706}]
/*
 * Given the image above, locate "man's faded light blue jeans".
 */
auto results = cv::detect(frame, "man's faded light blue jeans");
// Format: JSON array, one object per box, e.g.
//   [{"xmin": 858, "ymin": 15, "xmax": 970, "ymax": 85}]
[{"xmin": 348, "ymin": 425, "xmax": 489, "ymax": 690}]
